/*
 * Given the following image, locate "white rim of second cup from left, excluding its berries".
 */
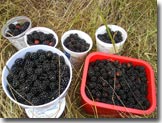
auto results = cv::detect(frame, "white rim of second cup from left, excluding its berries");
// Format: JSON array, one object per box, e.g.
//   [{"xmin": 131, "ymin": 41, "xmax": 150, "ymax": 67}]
[{"xmin": 24, "ymin": 27, "xmax": 58, "ymax": 47}]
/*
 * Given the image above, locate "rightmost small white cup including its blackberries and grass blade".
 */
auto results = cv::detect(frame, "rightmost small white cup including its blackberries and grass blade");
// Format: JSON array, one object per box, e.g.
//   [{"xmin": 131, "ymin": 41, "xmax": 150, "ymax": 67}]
[{"xmin": 95, "ymin": 25, "xmax": 127, "ymax": 54}]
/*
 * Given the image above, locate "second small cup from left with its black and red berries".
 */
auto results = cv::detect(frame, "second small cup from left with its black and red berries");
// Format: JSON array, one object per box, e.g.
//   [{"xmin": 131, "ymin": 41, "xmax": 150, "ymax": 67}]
[{"xmin": 24, "ymin": 27, "xmax": 58, "ymax": 47}]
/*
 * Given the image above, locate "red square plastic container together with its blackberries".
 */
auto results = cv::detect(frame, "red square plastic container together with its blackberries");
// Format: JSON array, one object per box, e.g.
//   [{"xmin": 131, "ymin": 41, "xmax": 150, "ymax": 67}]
[{"xmin": 80, "ymin": 52, "xmax": 156, "ymax": 117}]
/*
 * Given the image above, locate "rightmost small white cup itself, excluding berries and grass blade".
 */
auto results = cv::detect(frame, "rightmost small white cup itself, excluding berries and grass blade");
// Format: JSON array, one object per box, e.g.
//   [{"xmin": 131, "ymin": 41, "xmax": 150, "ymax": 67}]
[{"xmin": 95, "ymin": 25, "xmax": 127, "ymax": 54}]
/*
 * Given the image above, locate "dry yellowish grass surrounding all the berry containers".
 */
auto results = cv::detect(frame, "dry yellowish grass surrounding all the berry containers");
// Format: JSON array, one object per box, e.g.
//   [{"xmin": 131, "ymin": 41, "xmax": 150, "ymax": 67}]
[{"xmin": 0, "ymin": 0, "xmax": 157, "ymax": 118}]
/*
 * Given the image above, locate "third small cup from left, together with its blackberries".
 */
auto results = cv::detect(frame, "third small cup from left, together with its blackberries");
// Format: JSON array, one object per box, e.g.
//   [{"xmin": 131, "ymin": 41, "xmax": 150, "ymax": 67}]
[{"xmin": 61, "ymin": 30, "xmax": 93, "ymax": 69}]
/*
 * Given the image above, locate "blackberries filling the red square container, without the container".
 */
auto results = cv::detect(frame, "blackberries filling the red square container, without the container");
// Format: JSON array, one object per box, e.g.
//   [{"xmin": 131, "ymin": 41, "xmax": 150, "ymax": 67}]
[{"xmin": 86, "ymin": 60, "xmax": 150, "ymax": 110}]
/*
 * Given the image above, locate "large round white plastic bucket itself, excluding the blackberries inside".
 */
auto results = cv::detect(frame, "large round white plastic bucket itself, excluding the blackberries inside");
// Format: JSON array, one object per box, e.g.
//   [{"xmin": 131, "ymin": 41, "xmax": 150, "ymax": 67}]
[{"xmin": 2, "ymin": 45, "xmax": 72, "ymax": 118}]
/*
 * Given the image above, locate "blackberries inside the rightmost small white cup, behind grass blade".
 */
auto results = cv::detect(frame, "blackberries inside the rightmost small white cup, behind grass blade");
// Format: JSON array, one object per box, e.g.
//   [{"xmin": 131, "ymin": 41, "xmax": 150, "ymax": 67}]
[{"xmin": 97, "ymin": 29, "xmax": 123, "ymax": 44}]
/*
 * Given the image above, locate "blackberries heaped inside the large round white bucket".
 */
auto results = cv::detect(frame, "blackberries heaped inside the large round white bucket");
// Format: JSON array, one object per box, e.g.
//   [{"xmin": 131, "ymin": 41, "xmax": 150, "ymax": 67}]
[{"xmin": 7, "ymin": 50, "xmax": 70, "ymax": 105}]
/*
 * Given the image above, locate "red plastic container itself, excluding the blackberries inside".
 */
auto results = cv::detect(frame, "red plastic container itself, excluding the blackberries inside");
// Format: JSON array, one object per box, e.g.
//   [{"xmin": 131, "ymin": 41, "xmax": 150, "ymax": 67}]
[{"xmin": 80, "ymin": 52, "xmax": 156, "ymax": 117}]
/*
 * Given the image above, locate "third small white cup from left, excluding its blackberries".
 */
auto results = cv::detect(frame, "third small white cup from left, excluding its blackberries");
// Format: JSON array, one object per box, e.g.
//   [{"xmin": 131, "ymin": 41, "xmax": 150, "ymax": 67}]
[{"xmin": 61, "ymin": 30, "xmax": 93, "ymax": 69}]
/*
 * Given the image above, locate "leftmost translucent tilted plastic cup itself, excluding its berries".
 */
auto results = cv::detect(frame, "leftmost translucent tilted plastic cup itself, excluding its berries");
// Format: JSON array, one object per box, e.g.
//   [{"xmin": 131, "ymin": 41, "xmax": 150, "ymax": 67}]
[{"xmin": 1, "ymin": 16, "xmax": 32, "ymax": 50}]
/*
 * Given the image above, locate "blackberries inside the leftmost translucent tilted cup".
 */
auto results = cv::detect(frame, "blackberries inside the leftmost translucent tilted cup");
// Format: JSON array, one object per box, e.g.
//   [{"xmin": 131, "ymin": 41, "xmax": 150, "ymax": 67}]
[{"xmin": 6, "ymin": 21, "xmax": 30, "ymax": 37}]
